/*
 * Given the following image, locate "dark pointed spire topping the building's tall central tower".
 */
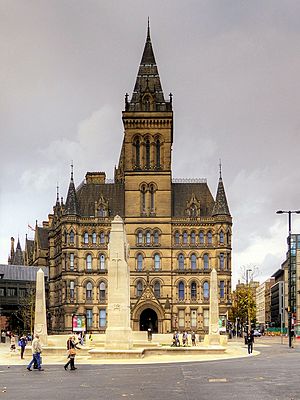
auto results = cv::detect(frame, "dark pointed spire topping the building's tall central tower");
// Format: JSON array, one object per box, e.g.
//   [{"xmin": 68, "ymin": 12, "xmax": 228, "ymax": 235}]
[{"xmin": 125, "ymin": 19, "xmax": 172, "ymax": 111}]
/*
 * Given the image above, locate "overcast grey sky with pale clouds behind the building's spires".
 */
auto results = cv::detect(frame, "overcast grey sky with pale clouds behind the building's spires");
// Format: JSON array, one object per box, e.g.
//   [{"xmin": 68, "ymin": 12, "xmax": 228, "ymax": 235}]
[{"xmin": 0, "ymin": 0, "xmax": 300, "ymax": 285}]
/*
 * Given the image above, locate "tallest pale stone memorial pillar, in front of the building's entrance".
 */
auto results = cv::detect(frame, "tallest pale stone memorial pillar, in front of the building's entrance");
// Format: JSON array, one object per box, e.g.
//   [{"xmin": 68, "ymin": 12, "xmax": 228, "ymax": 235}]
[{"xmin": 105, "ymin": 215, "xmax": 132, "ymax": 350}]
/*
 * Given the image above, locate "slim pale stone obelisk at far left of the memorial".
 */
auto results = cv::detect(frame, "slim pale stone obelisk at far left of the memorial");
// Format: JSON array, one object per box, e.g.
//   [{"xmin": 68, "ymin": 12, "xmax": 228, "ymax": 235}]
[{"xmin": 34, "ymin": 268, "xmax": 48, "ymax": 346}]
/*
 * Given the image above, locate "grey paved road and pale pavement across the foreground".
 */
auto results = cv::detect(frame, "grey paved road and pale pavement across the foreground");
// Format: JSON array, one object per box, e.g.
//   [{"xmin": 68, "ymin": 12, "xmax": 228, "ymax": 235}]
[{"xmin": 0, "ymin": 338, "xmax": 300, "ymax": 400}]
